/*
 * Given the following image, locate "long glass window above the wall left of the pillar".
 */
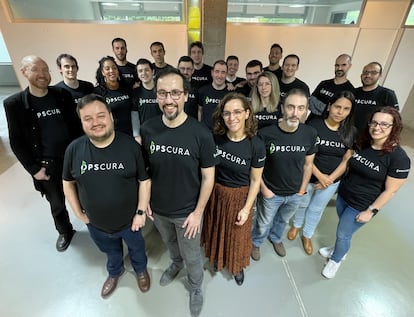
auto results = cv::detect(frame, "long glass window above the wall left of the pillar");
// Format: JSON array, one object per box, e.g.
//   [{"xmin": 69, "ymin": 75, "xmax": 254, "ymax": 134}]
[{"xmin": 8, "ymin": 0, "xmax": 184, "ymax": 22}]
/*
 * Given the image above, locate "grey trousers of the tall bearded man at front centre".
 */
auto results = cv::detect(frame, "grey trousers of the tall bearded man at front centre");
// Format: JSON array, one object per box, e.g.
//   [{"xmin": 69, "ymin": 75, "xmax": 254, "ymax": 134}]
[{"xmin": 154, "ymin": 214, "xmax": 204, "ymax": 289}]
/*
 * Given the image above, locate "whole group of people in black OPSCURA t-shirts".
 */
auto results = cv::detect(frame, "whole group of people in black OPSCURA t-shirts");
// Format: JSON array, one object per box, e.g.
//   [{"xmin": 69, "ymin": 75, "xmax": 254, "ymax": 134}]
[{"xmin": 4, "ymin": 38, "xmax": 410, "ymax": 316}]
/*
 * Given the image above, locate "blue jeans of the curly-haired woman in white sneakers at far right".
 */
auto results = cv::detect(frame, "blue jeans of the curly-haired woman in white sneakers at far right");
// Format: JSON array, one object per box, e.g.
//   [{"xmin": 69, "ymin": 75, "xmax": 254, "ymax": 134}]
[{"xmin": 331, "ymin": 195, "xmax": 365, "ymax": 263}]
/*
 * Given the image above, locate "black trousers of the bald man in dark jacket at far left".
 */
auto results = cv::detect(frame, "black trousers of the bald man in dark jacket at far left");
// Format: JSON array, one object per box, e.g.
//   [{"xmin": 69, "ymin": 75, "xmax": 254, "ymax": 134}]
[{"xmin": 35, "ymin": 162, "xmax": 73, "ymax": 234}]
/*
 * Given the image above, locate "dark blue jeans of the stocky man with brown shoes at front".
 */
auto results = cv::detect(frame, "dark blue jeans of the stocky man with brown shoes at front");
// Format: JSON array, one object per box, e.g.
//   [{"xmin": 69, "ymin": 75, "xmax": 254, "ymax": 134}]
[{"xmin": 87, "ymin": 224, "xmax": 147, "ymax": 277}]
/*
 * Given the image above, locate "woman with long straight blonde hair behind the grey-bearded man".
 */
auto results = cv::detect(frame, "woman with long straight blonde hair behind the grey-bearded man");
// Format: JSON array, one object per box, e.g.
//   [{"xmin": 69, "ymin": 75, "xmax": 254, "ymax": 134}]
[{"xmin": 251, "ymin": 71, "xmax": 280, "ymax": 129}]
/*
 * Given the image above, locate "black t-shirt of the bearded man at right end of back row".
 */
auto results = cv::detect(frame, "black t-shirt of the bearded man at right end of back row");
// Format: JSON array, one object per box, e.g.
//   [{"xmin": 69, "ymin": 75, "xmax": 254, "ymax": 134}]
[{"xmin": 354, "ymin": 86, "xmax": 399, "ymax": 134}]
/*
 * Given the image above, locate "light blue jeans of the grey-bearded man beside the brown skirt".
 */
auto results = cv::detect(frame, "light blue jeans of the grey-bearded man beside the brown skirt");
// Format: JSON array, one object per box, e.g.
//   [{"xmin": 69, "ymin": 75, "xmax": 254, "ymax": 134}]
[{"xmin": 252, "ymin": 194, "xmax": 304, "ymax": 247}]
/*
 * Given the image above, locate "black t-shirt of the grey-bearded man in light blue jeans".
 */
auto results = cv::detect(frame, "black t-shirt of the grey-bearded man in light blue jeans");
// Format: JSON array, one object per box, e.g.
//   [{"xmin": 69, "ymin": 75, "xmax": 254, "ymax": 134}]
[{"xmin": 258, "ymin": 123, "xmax": 317, "ymax": 196}]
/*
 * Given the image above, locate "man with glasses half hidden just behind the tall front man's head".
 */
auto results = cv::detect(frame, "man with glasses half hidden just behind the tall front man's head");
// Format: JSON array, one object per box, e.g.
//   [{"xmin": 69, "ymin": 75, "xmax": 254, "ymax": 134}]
[{"xmin": 177, "ymin": 56, "xmax": 198, "ymax": 119}]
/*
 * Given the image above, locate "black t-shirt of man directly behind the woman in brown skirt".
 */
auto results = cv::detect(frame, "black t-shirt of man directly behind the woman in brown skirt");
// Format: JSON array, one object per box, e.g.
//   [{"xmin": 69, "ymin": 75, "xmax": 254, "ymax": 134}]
[{"xmin": 198, "ymin": 84, "xmax": 229, "ymax": 130}]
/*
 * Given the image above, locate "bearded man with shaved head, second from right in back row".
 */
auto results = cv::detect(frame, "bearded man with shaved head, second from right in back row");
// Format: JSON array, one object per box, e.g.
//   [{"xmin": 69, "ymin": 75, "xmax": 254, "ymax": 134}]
[{"xmin": 309, "ymin": 54, "xmax": 355, "ymax": 116}]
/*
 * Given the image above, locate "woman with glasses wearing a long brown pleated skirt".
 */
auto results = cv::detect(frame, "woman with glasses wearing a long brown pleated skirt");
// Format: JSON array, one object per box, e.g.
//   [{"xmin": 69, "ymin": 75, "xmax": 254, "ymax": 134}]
[{"xmin": 201, "ymin": 93, "xmax": 266, "ymax": 285}]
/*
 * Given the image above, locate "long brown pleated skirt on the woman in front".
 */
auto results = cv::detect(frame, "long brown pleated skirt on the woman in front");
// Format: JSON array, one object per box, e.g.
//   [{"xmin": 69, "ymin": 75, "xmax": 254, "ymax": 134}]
[{"xmin": 201, "ymin": 183, "xmax": 252, "ymax": 275}]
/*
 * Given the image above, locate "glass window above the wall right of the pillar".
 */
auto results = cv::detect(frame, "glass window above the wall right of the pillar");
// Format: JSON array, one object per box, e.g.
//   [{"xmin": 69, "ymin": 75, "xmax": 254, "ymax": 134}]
[{"xmin": 227, "ymin": 0, "xmax": 364, "ymax": 24}]
